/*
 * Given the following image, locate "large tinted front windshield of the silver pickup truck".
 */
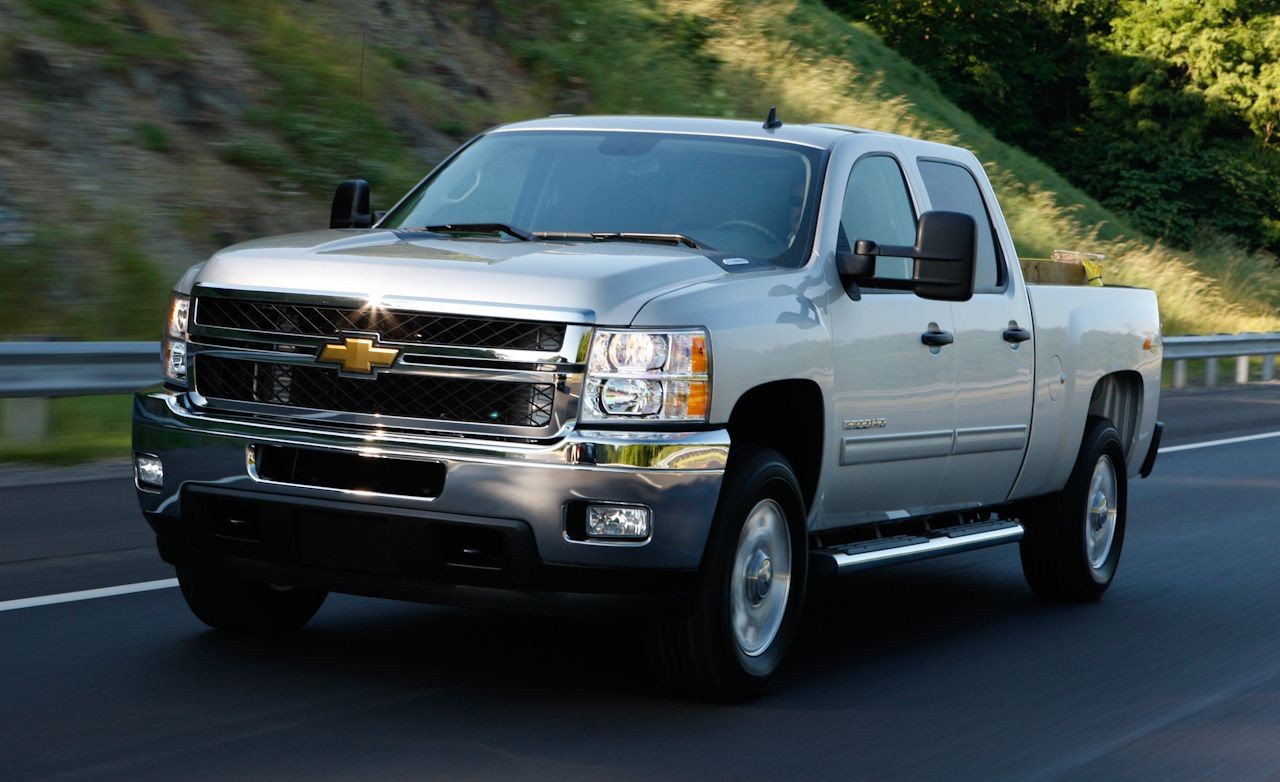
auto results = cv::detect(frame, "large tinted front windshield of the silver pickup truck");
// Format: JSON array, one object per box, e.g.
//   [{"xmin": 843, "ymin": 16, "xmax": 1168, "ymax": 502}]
[{"xmin": 380, "ymin": 131, "xmax": 823, "ymax": 266}]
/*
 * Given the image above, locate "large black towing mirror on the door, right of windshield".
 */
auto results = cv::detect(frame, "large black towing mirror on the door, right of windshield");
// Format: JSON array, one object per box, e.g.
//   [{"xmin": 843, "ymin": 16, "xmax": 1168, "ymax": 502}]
[{"xmin": 836, "ymin": 211, "xmax": 978, "ymax": 301}]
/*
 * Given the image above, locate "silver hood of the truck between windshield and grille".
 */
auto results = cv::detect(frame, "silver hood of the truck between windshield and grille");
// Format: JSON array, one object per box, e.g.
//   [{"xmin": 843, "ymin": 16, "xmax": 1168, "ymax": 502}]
[{"xmin": 193, "ymin": 230, "xmax": 727, "ymax": 325}]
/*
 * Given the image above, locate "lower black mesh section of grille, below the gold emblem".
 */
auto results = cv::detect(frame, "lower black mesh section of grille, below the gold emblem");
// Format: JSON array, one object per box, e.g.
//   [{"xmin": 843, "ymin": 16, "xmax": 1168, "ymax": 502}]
[{"xmin": 196, "ymin": 356, "xmax": 556, "ymax": 426}]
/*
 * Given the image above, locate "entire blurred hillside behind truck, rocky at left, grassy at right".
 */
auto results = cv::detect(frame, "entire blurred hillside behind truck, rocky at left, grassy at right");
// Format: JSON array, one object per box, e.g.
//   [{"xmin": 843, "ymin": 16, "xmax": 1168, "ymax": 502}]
[{"xmin": 0, "ymin": 0, "xmax": 1280, "ymax": 339}]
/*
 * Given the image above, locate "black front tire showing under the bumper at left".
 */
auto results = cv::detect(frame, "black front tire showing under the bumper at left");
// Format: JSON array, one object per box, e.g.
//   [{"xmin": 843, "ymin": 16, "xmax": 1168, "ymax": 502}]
[{"xmin": 178, "ymin": 566, "xmax": 329, "ymax": 635}]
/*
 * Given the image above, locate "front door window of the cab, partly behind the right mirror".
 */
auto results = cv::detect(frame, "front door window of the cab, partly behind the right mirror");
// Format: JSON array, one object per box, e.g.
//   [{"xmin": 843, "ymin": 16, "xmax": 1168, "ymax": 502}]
[{"xmin": 838, "ymin": 155, "xmax": 915, "ymax": 279}]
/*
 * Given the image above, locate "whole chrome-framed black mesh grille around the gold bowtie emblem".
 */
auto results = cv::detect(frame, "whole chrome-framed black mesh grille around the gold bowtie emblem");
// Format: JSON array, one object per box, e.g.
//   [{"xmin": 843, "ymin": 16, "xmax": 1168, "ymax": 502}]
[{"xmin": 189, "ymin": 287, "xmax": 590, "ymax": 439}]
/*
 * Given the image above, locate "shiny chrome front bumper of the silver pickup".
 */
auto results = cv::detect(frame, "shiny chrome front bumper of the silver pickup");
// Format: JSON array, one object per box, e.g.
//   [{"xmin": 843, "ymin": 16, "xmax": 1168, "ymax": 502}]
[{"xmin": 133, "ymin": 389, "xmax": 730, "ymax": 570}]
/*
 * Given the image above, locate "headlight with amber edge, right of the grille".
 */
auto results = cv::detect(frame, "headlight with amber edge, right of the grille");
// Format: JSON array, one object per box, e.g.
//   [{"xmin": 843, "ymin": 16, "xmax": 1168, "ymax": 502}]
[{"xmin": 581, "ymin": 329, "xmax": 710, "ymax": 421}]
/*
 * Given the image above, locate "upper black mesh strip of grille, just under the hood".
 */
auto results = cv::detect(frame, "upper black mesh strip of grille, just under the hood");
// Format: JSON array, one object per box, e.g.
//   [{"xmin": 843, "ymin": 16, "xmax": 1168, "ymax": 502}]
[{"xmin": 196, "ymin": 297, "xmax": 564, "ymax": 351}]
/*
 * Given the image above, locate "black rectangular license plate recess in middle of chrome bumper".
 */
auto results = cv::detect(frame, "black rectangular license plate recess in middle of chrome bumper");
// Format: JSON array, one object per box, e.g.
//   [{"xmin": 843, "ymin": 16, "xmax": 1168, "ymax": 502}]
[{"xmin": 248, "ymin": 444, "xmax": 445, "ymax": 499}]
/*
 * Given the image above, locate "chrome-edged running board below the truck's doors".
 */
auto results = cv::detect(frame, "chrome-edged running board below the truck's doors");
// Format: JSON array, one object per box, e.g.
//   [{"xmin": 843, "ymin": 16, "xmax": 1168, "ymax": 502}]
[{"xmin": 809, "ymin": 521, "xmax": 1023, "ymax": 576}]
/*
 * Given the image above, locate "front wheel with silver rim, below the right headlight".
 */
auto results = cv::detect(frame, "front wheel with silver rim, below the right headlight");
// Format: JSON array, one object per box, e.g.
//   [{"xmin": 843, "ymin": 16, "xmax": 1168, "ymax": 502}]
[{"xmin": 658, "ymin": 445, "xmax": 809, "ymax": 700}]
